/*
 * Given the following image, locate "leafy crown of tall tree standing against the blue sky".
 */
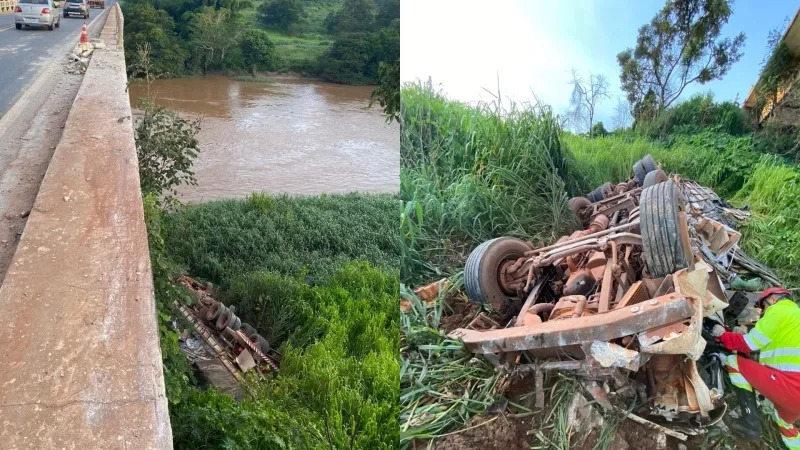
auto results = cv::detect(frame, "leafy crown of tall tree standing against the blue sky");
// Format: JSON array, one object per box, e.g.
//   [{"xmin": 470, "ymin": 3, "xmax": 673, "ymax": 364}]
[{"xmin": 617, "ymin": 0, "xmax": 745, "ymax": 119}]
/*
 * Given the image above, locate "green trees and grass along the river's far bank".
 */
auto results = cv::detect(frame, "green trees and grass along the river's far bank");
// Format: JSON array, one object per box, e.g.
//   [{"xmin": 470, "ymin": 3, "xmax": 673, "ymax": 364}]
[{"xmin": 123, "ymin": 0, "xmax": 400, "ymax": 90}]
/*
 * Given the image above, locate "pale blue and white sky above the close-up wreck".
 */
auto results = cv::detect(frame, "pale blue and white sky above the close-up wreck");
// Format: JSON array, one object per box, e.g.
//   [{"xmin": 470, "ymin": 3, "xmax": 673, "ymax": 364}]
[{"xmin": 400, "ymin": 0, "xmax": 800, "ymax": 129}]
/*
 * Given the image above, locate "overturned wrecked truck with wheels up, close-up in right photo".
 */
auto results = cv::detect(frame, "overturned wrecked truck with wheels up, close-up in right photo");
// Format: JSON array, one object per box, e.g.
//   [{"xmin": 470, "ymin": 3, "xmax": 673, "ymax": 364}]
[{"xmin": 451, "ymin": 155, "xmax": 778, "ymax": 439}]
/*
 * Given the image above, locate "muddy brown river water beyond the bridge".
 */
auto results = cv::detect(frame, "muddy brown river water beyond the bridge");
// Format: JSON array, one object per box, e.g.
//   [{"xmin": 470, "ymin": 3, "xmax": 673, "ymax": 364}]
[{"xmin": 130, "ymin": 76, "xmax": 400, "ymax": 202}]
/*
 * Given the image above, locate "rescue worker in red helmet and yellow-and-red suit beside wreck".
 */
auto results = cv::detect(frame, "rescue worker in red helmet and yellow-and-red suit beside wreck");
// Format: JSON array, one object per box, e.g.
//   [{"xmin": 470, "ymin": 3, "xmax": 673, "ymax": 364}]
[{"xmin": 713, "ymin": 287, "xmax": 800, "ymax": 449}]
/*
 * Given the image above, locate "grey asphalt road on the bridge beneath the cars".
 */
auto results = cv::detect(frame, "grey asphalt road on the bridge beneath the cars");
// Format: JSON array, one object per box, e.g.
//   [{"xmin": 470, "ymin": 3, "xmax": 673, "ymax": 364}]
[{"xmin": 0, "ymin": 1, "xmax": 113, "ymax": 117}]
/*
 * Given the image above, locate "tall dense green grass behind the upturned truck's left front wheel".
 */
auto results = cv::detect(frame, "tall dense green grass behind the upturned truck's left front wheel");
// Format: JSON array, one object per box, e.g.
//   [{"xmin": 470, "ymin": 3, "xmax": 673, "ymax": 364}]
[{"xmin": 400, "ymin": 85, "xmax": 584, "ymax": 281}]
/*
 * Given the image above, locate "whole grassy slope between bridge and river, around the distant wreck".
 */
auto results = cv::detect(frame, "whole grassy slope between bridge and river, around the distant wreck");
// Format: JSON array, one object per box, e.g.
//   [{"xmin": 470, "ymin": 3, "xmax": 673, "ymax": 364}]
[{"xmin": 146, "ymin": 194, "xmax": 399, "ymax": 449}]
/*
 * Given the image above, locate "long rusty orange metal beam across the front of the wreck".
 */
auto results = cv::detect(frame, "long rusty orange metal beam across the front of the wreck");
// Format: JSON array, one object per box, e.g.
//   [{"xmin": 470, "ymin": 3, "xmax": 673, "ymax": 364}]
[{"xmin": 450, "ymin": 293, "xmax": 694, "ymax": 354}]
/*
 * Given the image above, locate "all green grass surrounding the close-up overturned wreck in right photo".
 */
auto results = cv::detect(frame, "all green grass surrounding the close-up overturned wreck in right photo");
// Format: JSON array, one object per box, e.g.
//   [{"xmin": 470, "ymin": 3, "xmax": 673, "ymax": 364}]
[{"xmin": 400, "ymin": 83, "xmax": 800, "ymax": 448}]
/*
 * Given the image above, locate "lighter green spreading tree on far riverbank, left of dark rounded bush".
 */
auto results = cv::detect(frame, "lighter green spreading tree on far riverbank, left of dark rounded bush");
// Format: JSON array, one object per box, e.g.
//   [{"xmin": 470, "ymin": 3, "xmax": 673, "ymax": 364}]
[{"xmin": 189, "ymin": 7, "xmax": 244, "ymax": 72}]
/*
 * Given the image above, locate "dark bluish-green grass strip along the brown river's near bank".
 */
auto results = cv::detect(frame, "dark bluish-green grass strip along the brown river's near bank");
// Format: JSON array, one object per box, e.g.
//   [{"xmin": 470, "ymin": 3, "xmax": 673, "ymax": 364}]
[{"xmin": 164, "ymin": 194, "xmax": 400, "ymax": 288}]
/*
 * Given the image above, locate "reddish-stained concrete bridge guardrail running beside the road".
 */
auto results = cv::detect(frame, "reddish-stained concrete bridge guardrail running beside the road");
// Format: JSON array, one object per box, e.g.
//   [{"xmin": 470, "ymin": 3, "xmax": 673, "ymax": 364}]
[{"xmin": 0, "ymin": 5, "xmax": 172, "ymax": 449}]
